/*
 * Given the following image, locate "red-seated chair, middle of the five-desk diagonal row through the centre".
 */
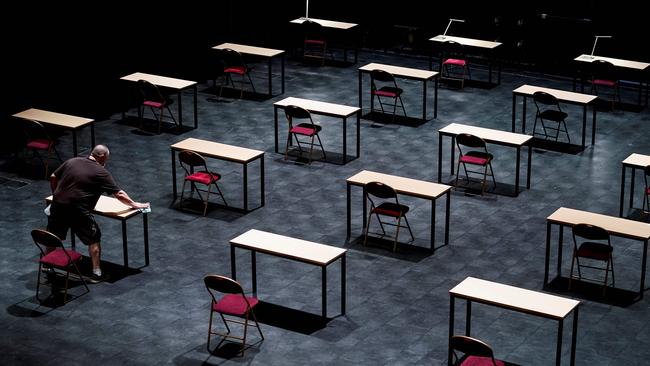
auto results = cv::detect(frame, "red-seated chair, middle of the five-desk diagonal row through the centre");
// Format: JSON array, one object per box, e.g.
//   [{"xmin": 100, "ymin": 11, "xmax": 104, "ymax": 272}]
[{"xmin": 454, "ymin": 133, "xmax": 497, "ymax": 196}]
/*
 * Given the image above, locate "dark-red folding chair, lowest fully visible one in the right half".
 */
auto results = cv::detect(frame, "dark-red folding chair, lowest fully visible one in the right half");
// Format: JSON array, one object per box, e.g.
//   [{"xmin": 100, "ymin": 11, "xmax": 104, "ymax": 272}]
[{"xmin": 569, "ymin": 224, "xmax": 616, "ymax": 296}]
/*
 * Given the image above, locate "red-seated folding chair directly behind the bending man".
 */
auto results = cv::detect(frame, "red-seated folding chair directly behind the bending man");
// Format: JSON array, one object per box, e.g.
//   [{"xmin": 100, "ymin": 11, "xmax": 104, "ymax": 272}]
[{"xmin": 32, "ymin": 229, "xmax": 90, "ymax": 303}]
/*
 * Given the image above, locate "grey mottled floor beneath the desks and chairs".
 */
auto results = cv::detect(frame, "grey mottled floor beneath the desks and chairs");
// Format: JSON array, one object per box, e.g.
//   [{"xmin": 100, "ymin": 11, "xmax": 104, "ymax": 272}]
[{"xmin": 0, "ymin": 52, "xmax": 650, "ymax": 365}]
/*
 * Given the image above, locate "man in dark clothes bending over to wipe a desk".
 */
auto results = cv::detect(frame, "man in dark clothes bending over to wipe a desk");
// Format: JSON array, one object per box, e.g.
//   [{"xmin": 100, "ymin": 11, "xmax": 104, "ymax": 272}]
[{"xmin": 47, "ymin": 145, "xmax": 149, "ymax": 283}]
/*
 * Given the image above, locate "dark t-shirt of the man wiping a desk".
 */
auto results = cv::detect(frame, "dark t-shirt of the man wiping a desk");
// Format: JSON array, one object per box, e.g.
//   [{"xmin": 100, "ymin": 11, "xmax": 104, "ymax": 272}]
[{"xmin": 54, "ymin": 157, "xmax": 120, "ymax": 211}]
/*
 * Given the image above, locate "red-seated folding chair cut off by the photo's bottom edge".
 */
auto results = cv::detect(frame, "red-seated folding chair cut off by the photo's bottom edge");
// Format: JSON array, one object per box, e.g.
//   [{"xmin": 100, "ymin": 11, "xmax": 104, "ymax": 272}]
[{"xmin": 449, "ymin": 335, "xmax": 506, "ymax": 366}]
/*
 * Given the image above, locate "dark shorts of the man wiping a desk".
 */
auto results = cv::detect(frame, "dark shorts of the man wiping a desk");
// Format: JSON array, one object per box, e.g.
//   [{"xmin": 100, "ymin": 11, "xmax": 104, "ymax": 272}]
[{"xmin": 47, "ymin": 202, "xmax": 102, "ymax": 245}]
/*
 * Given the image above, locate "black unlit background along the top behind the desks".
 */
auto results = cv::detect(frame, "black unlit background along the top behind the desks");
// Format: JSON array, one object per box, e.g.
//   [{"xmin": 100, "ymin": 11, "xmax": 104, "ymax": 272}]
[{"xmin": 0, "ymin": 0, "xmax": 650, "ymax": 123}]
